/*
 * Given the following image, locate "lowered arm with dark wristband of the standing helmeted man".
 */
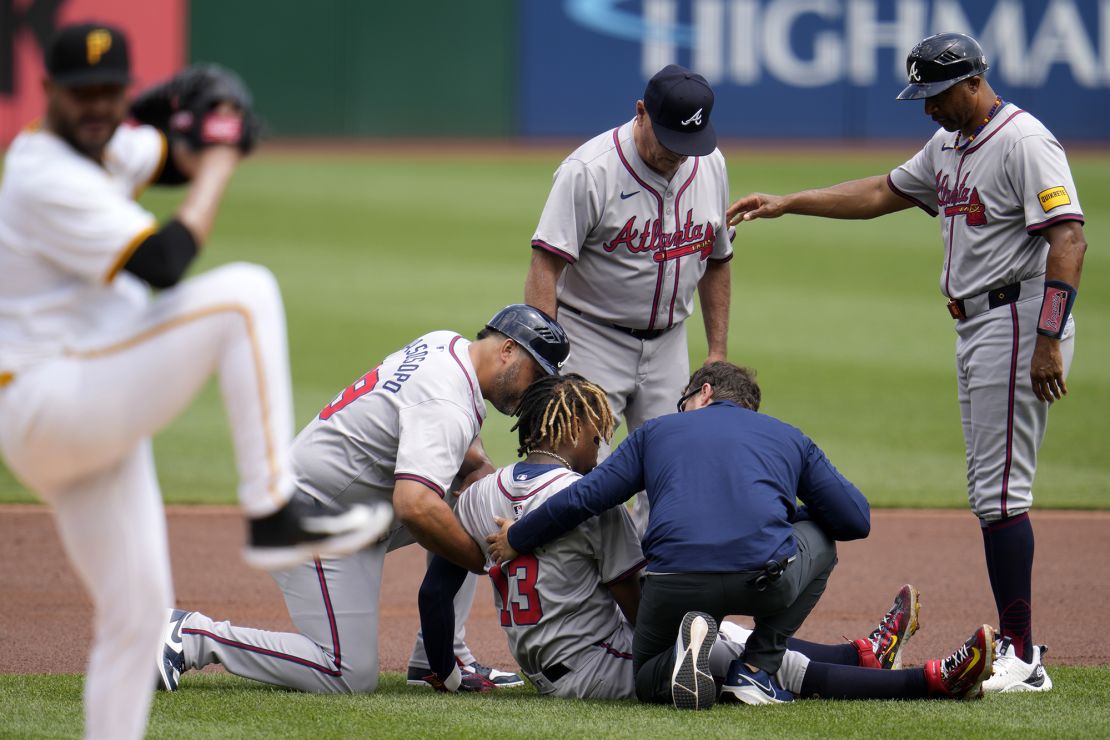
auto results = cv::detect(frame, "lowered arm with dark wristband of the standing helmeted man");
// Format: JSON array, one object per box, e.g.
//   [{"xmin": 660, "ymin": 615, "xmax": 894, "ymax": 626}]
[{"xmin": 1029, "ymin": 221, "xmax": 1087, "ymax": 403}]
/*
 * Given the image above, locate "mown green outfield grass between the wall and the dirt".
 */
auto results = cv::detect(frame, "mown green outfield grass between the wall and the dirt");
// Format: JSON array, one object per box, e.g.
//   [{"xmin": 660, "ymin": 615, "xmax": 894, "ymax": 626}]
[{"xmin": 0, "ymin": 145, "xmax": 1110, "ymax": 508}]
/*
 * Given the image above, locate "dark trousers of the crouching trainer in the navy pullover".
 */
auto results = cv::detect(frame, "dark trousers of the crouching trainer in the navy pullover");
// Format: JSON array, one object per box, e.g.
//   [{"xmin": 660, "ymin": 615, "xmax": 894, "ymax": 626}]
[{"xmin": 633, "ymin": 521, "xmax": 837, "ymax": 703}]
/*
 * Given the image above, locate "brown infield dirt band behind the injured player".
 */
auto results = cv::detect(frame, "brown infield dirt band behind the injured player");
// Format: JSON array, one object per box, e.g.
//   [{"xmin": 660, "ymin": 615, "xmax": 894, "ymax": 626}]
[{"xmin": 0, "ymin": 505, "xmax": 1110, "ymax": 673}]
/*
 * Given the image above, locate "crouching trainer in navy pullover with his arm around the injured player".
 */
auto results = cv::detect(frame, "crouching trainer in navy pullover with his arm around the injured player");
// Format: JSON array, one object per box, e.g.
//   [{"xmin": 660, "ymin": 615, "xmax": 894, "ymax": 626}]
[{"xmin": 488, "ymin": 362, "xmax": 870, "ymax": 708}]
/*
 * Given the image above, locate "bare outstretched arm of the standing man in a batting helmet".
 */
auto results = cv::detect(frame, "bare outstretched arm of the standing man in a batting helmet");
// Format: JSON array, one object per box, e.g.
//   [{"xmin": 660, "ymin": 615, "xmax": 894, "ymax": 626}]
[{"xmin": 727, "ymin": 175, "xmax": 912, "ymax": 226}]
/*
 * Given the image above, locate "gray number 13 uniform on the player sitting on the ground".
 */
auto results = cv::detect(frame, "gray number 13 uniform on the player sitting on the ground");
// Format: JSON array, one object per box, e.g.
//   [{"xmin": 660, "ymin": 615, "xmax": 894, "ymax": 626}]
[{"xmin": 455, "ymin": 463, "xmax": 644, "ymax": 699}]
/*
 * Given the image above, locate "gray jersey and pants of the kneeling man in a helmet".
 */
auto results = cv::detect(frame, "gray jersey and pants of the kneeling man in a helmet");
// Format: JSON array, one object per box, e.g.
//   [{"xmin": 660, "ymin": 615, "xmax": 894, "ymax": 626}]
[{"xmin": 181, "ymin": 332, "xmax": 486, "ymax": 693}]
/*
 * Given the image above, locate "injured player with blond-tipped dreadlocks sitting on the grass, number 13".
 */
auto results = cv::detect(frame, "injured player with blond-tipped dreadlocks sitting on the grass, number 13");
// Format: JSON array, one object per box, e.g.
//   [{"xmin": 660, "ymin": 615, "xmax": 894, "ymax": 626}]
[{"xmin": 420, "ymin": 375, "xmax": 993, "ymax": 703}]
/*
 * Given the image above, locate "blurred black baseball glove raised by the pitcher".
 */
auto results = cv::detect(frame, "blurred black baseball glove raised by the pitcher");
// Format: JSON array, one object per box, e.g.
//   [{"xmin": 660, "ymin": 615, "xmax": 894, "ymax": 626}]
[{"xmin": 131, "ymin": 64, "xmax": 262, "ymax": 154}]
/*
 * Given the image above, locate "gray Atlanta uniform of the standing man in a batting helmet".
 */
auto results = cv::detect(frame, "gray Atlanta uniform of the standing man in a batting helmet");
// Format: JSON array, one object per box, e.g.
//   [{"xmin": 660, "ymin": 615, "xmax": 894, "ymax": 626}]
[{"xmin": 888, "ymin": 104, "xmax": 1083, "ymax": 521}]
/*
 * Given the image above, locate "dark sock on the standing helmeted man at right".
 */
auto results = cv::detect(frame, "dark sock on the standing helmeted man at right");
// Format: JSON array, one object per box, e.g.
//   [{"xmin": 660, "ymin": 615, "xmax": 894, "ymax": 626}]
[{"xmin": 983, "ymin": 513, "xmax": 1033, "ymax": 661}]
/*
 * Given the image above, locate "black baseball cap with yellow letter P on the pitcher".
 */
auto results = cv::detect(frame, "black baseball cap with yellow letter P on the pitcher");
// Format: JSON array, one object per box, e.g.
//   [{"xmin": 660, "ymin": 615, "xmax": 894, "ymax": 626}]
[{"xmin": 46, "ymin": 23, "xmax": 131, "ymax": 88}]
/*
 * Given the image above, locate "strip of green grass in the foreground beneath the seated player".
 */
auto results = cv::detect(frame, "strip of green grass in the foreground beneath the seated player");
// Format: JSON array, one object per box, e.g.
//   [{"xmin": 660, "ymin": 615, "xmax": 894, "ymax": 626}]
[{"xmin": 0, "ymin": 666, "xmax": 1110, "ymax": 738}]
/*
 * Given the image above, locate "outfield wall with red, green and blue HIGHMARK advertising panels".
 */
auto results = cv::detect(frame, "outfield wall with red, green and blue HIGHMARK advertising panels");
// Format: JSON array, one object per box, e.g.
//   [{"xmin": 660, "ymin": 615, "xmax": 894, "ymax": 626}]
[{"xmin": 0, "ymin": 0, "xmax": 1110, "ymax": 145}]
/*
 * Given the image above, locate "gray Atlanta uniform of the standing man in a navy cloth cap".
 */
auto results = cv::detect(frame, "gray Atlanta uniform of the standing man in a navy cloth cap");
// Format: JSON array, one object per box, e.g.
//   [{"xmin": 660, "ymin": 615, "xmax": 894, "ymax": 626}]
[{"xmin": 532, "ymin": 122, "xmax": 733, "ymax": 530}]
